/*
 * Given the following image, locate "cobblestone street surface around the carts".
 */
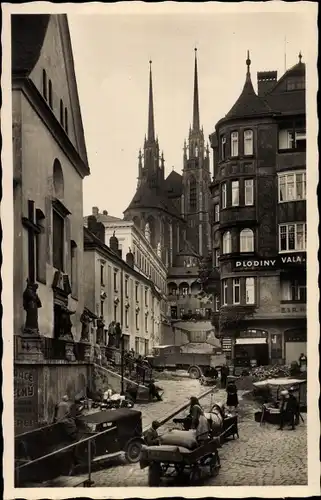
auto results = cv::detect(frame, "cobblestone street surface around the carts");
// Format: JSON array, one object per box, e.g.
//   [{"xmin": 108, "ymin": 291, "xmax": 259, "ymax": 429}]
[{"xmin": 88, "ymin": 377, "xmax": 307, "ymax": 487}]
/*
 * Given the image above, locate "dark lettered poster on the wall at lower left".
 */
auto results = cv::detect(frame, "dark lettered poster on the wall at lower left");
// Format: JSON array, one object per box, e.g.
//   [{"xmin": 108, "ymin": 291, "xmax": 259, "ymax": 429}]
[{"xmin": 14, "ymin": 366, "xmax": 38, "ymax": 435}]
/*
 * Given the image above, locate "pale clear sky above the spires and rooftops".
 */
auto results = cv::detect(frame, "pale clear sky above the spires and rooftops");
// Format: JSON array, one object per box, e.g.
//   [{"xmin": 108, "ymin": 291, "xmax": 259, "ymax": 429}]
[{"xmin": 68, "ymin": 7, "xmax": 311, "ymax": 218}]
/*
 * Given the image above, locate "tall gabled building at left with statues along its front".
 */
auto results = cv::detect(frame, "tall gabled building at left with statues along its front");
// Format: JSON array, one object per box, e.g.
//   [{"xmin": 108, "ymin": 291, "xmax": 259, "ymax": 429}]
[{"xmin": 12, "ymin": 14, "xmax": 90, "ymax": 432}]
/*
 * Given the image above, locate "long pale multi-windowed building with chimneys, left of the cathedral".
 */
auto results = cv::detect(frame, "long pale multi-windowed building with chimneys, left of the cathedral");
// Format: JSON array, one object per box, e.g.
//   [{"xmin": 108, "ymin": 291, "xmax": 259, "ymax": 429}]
[{"xmin": 84, "ymin": 221, "xmax": 165, "ymax": 355}]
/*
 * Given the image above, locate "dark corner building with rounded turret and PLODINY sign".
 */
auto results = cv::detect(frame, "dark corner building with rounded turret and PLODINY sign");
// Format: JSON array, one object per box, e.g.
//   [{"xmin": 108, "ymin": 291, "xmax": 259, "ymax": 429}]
[{"xmin": 210, "ymin": 54, "xmax": 307, "ymax": 366}]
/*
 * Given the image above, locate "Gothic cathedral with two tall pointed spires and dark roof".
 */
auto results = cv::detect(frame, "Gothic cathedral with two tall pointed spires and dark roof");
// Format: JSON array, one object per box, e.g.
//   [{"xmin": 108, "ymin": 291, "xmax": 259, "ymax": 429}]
[{"xmin": 124, "ymin": 49, "xmax": 211, "ymax": 268}]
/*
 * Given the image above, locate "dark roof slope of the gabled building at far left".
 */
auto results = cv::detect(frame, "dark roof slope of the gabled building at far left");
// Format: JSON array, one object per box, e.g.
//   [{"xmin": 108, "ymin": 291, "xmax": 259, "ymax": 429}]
[{"xmin": 11, "ymin": 14, "xmax": 50, "ymax": 75}]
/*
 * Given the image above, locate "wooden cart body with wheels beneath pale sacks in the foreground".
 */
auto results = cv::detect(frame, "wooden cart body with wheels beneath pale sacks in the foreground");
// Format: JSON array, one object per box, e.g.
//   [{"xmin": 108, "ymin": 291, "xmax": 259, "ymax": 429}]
[{"xmin": 140, "ymin": 437, "xmax": 220, "ymax": 486}]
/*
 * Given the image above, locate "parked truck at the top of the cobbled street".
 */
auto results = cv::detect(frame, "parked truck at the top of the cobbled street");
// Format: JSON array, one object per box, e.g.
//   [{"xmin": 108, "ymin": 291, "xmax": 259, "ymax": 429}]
[{"xmin": 147, "ymin": 342, "xmax": 226, "ymax": 378}]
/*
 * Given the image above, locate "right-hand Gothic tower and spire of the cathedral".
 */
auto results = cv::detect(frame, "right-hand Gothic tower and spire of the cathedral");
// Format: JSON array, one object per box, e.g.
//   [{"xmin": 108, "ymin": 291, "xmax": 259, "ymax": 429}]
[{"xmin": 181, "ymin": 49, "xmax": 211, "ymax": 256}]
